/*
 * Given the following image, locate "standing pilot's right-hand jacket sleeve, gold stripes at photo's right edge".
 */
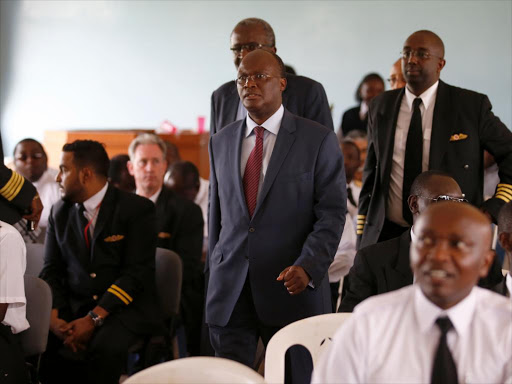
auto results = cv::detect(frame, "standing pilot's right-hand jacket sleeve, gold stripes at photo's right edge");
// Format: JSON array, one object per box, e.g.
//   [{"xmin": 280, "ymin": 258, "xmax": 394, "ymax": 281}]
[{"xmin": 479, "ymin": 95, "xmax": 512, "ymax": 222}]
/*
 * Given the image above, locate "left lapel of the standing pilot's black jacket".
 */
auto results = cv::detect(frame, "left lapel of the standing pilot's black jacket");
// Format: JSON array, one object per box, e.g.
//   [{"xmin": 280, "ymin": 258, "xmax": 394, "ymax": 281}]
[{"xmin": 377, "ymin": 89, "xmax": 405, "ymax": 186}]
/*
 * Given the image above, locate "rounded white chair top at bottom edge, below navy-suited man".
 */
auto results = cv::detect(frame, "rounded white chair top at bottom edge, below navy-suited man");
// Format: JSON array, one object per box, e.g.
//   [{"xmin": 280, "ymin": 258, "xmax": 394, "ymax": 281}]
[{"xmin": 124, "ymin": 356, "xmax": 265, "ymax": 384}]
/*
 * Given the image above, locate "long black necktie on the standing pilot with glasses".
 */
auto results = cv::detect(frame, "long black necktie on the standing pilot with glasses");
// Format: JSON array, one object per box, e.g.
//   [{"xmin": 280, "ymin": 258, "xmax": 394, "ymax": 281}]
[{"xmin": 402, "ymin": 97, "xmax": 423, "ymax": 225}]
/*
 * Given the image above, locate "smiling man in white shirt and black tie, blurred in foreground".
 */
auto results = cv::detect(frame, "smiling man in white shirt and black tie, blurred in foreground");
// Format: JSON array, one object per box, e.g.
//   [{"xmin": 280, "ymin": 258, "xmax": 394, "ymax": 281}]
[{"xmin": 312, "ymin": 202, "xmax": 512, "ymax": 383}]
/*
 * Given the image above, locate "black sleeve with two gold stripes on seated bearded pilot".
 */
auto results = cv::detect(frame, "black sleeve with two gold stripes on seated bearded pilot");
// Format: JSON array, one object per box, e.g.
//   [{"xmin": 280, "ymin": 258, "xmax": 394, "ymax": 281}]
[{"xmin": 98, "ymin": 200, "xmax": 157, "ymax": 313}]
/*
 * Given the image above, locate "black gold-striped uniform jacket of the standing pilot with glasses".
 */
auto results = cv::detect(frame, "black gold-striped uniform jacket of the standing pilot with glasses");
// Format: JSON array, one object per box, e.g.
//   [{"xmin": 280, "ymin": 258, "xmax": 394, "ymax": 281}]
[{"xmin": 357, "ymin": 80, "xmax": 512, "ymax": 248}]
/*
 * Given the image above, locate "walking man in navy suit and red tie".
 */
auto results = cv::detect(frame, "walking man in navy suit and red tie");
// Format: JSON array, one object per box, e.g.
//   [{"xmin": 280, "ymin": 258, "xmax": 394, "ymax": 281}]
[{"xmin": 206, "ymin": 49, "xmax": 347, "ymax": 366}]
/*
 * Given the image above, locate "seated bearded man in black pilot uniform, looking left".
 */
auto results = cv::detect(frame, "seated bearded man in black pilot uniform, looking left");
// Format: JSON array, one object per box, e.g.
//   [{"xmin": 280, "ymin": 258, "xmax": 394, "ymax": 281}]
[{"xmin": 41, "ymin": 140, "xmax": 158, "ymax": 384}]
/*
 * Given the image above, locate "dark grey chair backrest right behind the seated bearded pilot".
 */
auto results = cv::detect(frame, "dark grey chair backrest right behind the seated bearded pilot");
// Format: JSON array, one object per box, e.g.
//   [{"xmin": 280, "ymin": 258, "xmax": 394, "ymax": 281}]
[{"xmin": 155, "ymin": 248, "xmax": 183, "ymax": 319}]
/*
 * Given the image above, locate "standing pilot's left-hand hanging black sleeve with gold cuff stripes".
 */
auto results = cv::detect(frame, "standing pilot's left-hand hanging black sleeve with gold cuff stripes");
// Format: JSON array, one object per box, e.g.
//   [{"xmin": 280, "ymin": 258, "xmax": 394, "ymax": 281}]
[{"xmin": 356, "ymin": 105, "xmax": 377, "ymax": 245}]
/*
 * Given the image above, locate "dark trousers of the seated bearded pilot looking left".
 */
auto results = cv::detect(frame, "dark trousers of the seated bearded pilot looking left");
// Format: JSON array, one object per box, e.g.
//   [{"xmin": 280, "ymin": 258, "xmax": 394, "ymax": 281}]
[{"xmin": 41, "ymin": 316, "xmax": 140, "ymax": 384}]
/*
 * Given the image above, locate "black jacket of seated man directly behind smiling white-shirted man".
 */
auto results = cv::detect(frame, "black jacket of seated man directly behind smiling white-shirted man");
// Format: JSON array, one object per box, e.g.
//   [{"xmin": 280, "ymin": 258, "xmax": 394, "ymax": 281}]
[{"xmin": 338, "ymin": 229, "xmax": 506, "ymax": 312}]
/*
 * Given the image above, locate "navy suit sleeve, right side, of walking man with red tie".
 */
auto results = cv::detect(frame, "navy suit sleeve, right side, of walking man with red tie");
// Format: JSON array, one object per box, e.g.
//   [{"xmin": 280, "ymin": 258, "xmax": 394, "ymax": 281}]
[{"xmin": 294, "ymin": 131, "xmax": 347, "ymax": 287}]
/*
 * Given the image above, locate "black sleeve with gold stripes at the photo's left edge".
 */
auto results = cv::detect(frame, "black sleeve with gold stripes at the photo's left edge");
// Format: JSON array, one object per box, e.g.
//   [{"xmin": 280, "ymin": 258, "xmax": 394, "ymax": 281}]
[{"xmin": 0, "ymin": 134, "xmax": 37, "ymax": 224}]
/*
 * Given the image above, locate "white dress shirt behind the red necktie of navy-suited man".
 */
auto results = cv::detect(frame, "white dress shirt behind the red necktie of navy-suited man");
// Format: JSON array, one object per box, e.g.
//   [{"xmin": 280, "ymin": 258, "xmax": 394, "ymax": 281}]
[{"xmin": 240, "ymin": 105, "xmax": 284, "ymax": 196}]
